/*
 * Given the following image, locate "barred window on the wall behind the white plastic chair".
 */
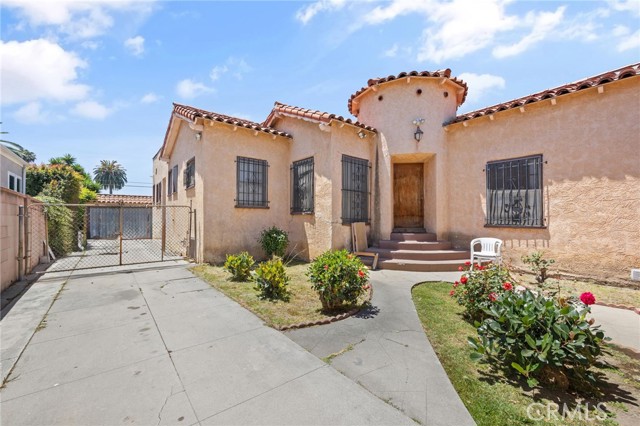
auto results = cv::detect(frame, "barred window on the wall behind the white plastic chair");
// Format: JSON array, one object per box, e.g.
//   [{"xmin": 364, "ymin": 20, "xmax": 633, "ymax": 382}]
[{"xmin": 486, "ymin": 155, "xmax": 544, "ymax": 227}]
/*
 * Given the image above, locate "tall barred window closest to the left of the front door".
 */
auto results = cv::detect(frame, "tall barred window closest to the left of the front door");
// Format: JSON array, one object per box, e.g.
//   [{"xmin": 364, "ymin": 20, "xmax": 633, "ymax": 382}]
[{"xmin": 342, "ymin": 155, "xmax": 369, "ymax": 223}]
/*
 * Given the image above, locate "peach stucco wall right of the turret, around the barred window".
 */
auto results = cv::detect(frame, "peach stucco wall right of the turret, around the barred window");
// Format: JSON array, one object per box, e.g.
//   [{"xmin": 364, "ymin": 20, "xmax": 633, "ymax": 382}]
[{"xmin": 446, "ymin": 77, "xmax": 640, "ymax": 279}]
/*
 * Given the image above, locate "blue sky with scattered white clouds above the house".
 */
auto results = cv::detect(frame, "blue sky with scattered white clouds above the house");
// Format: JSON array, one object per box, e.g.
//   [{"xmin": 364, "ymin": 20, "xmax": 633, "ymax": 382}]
[{"xmin": 0, "ymin": 0, "xmax": 640, "ymax": 194}]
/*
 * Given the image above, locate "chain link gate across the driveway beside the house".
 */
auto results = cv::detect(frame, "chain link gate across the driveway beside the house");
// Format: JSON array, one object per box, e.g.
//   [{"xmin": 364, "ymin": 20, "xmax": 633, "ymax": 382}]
[{"xmin": 26, "ymin": 203, "xmax": 195, "ymax": 272}]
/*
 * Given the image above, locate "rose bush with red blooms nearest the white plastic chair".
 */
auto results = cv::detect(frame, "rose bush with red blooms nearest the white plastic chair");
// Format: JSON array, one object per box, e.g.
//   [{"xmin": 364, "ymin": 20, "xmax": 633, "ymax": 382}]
[{"xmin": 450, "ymin": 262, "xmax": 513, "ymax": 321}]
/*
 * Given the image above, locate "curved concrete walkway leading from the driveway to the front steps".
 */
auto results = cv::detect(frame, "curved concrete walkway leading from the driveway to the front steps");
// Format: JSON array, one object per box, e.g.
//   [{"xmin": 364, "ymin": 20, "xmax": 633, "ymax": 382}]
[{"xmin": 286, "ymin": 270, "xmax": 475, "ymax": 426}]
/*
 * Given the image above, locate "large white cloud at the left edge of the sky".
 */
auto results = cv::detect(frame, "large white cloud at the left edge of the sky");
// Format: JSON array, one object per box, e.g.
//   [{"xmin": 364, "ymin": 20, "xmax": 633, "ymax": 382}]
[{"xmin": 0, "ymin": 39, "xmax": 89, "ymax": 104}]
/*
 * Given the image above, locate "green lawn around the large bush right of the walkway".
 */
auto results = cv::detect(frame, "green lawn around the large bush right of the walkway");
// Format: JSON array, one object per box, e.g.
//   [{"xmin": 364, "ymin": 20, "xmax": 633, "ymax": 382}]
[{"xmin": 413, "ymin": 282, "xmax": 640, "ymax": 426}]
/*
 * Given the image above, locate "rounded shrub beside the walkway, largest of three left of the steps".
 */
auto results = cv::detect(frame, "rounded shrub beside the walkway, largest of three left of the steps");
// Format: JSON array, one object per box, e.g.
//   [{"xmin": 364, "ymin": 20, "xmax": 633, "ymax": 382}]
[{"xmin": 307, "ymin": 250, "xmax": 369, "ymax": 309}]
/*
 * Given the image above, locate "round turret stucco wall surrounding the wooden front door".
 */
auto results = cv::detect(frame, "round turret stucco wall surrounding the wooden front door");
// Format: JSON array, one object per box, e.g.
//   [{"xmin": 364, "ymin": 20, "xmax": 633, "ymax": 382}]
[{"xmin": 358, "ymin": 77, "xmax": 460, "ymax": 239}]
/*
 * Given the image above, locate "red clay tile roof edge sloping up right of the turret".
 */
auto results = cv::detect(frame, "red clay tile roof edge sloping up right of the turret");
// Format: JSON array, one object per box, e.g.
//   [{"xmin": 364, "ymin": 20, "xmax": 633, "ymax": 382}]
[{"xmin": 445, "ymin": 63, "xmax": 640, "ymax": 126}]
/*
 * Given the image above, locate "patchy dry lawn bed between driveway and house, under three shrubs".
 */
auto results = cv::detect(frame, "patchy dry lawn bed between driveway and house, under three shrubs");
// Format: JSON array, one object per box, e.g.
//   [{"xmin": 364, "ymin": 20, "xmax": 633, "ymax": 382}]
[{"xmin": 191, "ymin": 263, "xmax": 365, "ymax": 328}]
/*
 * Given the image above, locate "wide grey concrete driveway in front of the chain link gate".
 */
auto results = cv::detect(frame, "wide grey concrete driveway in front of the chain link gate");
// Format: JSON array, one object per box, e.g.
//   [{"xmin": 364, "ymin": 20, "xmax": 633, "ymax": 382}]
[{"xmin": 0, "ymin": 262, "xmax": 415, "ymax": 425}]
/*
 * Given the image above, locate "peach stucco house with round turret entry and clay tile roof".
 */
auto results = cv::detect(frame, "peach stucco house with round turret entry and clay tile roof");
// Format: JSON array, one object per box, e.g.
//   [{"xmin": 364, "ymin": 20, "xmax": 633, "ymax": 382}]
[{"xmin": 154, "ymin": 64, "xmax": 640, "ymax": 279}]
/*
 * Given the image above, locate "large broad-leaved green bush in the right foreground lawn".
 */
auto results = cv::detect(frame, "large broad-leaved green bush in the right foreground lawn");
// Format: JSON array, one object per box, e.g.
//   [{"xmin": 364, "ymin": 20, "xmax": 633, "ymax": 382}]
[{"xmin": 469, "ymin": 289, "xmax": 604, "ymax": 389}]
